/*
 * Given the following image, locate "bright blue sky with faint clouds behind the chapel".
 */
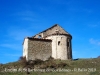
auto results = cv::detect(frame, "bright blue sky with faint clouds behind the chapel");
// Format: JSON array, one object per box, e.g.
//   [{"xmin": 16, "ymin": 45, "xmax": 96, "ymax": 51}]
[{"xmin": 0, "ymin": 0, "xmax": 100, "ymax": 63}]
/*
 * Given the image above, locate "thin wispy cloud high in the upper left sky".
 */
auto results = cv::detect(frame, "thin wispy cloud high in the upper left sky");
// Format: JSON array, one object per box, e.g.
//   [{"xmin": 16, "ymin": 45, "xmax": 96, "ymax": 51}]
[{"xmin": 10, "ymin": 10, "xmax": 39, "ymax": 22}]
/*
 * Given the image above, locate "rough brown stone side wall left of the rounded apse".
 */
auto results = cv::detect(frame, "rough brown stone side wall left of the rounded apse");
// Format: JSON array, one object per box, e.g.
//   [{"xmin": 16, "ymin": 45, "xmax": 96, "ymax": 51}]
[{"xmin": 28, "ymin": 39, "xmax": 52, "ymax": 60}]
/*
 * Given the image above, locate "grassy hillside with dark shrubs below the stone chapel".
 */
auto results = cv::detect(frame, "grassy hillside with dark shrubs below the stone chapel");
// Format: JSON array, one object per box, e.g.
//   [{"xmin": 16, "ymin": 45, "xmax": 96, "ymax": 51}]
[{"xmin": 0, "ymin": 58, "xmax": 100, "ymax": 75}]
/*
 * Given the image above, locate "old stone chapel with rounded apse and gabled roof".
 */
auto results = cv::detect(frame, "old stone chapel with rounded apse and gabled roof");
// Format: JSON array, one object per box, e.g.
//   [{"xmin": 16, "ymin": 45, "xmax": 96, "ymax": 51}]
[{"xmin": 23, "ymin": 24, "xmax": 72, "ymax": 61}]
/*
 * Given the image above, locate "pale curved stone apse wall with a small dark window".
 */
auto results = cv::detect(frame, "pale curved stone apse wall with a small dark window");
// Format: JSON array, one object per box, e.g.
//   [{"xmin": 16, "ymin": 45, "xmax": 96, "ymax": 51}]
[{"xmin": 47, "ymin": 35, "xmax": 72, "ymax": 60}]
